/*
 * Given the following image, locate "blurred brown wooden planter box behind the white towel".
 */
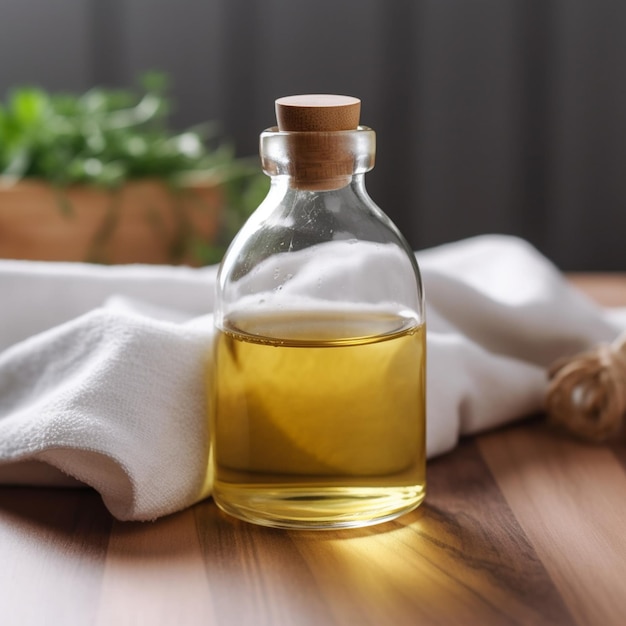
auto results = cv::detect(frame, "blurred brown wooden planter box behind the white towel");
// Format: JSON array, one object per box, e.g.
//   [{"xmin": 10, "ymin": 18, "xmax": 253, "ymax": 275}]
[{"xmin": 0, "ymin": 181, "xmax": 222, "ymax": 265}]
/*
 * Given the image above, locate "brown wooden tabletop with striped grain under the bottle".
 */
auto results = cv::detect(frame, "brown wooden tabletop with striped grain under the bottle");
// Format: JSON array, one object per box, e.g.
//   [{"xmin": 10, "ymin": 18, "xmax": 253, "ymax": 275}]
[{"xmin": 0, "ymin": 276, "xmax": 626, "ymax": 626}]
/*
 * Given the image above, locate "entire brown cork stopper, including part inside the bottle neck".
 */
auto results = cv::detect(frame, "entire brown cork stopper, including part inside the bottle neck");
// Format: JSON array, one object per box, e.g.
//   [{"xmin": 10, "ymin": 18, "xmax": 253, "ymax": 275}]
[{"xmin": 276, "ymin": 94, "xmax": 361, "ymax": 190}]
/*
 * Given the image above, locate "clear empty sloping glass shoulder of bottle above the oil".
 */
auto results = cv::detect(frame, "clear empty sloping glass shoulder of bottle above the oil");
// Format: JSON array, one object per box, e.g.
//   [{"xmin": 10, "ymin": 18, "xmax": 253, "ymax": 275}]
[{"xmin": 218, "ymin": 178, "xmax": 423, "ymax": 318}]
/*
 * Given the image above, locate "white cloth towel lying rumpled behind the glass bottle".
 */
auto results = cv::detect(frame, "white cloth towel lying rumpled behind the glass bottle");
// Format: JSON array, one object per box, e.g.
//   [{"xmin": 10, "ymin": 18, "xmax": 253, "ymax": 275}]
[{"xmin": 0, "ymin": 236, "xmax": 626, "ymax": 520}]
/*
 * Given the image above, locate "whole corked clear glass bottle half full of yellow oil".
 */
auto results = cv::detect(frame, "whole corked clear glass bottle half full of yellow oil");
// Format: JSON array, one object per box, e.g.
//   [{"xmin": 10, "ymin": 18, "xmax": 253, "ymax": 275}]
[{"xmin": 210, "ymin": 95, "xmax": 426, "ymax": 529}]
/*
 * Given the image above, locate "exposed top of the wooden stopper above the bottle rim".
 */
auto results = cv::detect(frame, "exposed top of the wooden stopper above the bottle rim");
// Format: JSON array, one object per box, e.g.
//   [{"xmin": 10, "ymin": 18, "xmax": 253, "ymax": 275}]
[{"xmin": 276, "ymin": 94, "xmax": 361, "ymax": 132}]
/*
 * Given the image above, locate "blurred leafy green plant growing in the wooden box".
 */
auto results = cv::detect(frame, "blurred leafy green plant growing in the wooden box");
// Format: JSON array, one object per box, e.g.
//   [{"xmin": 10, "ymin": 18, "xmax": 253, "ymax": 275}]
[{"xmin": 0, "ymin": 73, "xmax": 268, "ymax": 263}]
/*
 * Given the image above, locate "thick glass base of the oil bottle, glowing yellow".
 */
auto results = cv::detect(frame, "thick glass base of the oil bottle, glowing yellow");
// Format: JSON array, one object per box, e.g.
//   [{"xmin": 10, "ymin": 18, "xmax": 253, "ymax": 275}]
[{"xmin": 213, "ymin": 485, "xmax": 426, "ymax": 530}]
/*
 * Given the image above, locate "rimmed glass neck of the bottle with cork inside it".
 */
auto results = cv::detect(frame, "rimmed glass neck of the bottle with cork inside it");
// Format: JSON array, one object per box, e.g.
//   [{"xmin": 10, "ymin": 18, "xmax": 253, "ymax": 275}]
[{"xmin": 260, "ymin": 126, "xmax": 376, "ymax": 191}]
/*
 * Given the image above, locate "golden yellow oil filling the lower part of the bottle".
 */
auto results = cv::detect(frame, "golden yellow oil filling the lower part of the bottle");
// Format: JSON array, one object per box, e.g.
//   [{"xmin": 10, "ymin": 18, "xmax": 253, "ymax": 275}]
[{"xmin": 210, "ymin": 312, "xmax": 425, "ymax": 528}]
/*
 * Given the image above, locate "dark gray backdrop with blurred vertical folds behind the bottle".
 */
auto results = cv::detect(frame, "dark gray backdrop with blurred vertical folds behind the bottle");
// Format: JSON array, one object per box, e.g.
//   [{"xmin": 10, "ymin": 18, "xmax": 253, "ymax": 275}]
[{"xmin": 0, "ymin": 0, "xmax": 626, "ymax": 270}]
